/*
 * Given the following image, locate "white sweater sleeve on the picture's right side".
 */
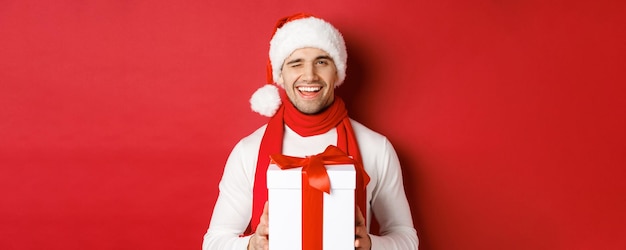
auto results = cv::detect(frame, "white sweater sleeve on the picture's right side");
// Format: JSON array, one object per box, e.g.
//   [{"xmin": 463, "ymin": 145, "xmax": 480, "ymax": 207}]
[{"xmin": 370, "ymin": 138, "xmax": 419, "ymax": 250}]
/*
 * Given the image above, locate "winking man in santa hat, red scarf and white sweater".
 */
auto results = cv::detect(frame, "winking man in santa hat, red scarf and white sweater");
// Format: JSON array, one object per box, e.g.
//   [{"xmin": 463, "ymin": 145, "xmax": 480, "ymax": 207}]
[{"xmin": 203, "ymin": 14, "xmax": 418, "ymax": 250}]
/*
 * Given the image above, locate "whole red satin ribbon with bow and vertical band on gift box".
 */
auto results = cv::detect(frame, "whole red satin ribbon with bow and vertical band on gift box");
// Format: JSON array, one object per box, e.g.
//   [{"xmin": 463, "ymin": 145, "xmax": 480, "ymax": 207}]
[{"xmin": 270, "ymin": 145, "xmax": 369, "ymax": 250}]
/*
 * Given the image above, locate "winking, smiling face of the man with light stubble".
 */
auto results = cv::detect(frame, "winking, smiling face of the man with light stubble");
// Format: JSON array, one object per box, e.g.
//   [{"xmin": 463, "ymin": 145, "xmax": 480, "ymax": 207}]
[{"xmin": 278, "ymin": 48, "xmax": 338, "ymax": 114}]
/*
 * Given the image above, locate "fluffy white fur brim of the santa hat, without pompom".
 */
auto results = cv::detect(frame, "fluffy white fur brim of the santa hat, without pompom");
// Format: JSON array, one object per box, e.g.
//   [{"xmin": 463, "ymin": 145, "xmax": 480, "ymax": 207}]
[{"xmin": 269, "ymin": 17, "xmax": 348, "ymax": 87}]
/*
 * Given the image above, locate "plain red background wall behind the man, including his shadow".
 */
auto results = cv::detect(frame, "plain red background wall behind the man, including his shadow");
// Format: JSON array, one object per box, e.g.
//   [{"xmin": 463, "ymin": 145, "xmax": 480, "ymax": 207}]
[{"xmin": 0, "ymin": 0, "xmax": 626, "ymax": 250}]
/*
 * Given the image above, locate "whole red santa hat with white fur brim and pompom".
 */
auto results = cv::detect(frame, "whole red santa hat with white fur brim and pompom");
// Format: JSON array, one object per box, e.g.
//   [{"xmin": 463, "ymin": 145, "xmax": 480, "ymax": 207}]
[{"xmin": 250, "ymin": 13, "xmax": 348, "ymax": 117}]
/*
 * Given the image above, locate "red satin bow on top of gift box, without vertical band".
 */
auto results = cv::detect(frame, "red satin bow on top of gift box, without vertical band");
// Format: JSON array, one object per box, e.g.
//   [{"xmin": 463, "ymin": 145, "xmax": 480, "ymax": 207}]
[{"xmin": 270, "ymin": 145, "xmax": 358, "ymax": 194}]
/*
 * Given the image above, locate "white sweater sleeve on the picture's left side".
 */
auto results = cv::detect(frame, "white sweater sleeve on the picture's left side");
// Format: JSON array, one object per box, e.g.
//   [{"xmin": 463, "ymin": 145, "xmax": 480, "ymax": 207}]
[{"xmin": 202, "ymin": 141, "xmax": 254, "ymax": 250}]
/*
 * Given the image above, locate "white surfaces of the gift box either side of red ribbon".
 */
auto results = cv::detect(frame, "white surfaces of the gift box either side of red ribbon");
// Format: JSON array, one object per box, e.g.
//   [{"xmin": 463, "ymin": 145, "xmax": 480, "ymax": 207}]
[{"xmin": 267, "ymin": 164, "xmax": 356, "ymax": 250}]
